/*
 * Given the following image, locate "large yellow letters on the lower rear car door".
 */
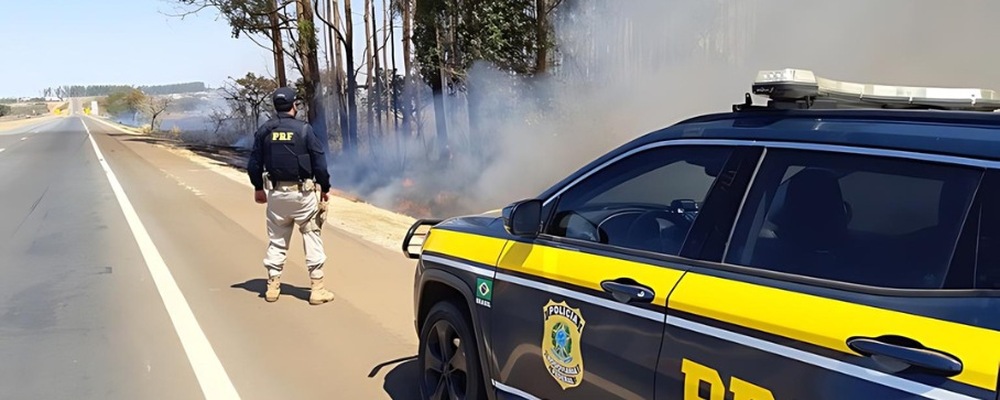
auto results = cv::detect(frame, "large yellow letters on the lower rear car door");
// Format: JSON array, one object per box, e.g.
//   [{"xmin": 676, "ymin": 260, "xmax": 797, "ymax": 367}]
[{"xmin": 681, "ymin": 358, "xmax": 774, "ymax": 400}]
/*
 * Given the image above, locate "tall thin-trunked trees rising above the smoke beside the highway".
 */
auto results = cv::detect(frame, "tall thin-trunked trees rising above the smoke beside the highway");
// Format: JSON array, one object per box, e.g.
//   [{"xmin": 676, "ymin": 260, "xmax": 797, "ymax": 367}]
[{"xmin": 176, "ymin": 0, "xmax": 579, "ymax": 155}]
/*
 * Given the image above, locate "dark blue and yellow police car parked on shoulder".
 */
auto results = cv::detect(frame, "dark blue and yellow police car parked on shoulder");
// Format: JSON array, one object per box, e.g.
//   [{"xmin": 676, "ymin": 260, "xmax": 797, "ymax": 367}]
[{"xmin": 403, "ymin": 69, "xmax": 1000, "ymax": 400}]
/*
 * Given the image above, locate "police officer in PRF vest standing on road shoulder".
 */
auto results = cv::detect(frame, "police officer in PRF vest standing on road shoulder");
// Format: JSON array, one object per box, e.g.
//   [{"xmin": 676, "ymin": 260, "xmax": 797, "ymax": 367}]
[{"xmin": 247, "ymin": 87, "xmax": 333, "ymax": 304}]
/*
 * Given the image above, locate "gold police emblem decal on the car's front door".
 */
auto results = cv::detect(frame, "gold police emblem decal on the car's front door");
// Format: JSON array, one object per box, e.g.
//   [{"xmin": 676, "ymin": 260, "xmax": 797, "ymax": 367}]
[{"xmin": 542, "ymin": 300, "xmax": 586, "ymax": 390}]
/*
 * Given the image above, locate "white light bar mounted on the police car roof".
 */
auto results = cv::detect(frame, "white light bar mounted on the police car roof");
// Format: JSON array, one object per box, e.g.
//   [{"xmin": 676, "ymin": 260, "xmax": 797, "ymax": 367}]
[{"xmin": 753, "ymin": 68, "xmax": 1000, "ymax": 111}]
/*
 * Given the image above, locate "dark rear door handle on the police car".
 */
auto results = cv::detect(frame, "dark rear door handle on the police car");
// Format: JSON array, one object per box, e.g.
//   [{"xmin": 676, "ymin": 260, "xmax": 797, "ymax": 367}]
[{"xmin": 847, "ymin": 337, "xmax": 962, "ymax": 376}]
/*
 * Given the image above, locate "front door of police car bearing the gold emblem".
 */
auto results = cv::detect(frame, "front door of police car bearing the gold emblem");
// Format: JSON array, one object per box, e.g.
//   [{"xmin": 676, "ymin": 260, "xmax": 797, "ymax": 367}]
[{"xmin": 491, "ymin": 143, "xmax": 734, "ymax": 399}]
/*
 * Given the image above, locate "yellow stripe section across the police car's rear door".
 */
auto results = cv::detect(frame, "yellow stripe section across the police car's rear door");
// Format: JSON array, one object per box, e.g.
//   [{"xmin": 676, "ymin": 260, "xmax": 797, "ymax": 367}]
[{"xmin": 657, "ymin": 273, "xmax": 1000, "ymax": 390}]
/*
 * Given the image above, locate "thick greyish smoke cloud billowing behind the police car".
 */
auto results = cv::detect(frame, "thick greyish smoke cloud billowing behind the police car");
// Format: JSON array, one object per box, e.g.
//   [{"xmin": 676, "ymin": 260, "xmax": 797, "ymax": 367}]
[{"xmin": 334, "ymin": 0, "xmax": 1000, "ymax": 217}]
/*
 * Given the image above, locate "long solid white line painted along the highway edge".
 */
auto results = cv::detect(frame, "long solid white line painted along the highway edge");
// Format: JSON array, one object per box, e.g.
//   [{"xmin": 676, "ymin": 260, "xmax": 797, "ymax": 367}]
[{"xmin": 80, "ymin": 118, "xmax": 240, "ymax": 399}]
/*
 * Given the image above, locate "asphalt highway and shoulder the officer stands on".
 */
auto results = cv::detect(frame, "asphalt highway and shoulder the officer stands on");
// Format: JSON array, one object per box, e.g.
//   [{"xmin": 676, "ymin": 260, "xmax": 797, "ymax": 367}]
[{"xmin": 0, "ymin": 115, "xmax": 417, "ymax": 399}]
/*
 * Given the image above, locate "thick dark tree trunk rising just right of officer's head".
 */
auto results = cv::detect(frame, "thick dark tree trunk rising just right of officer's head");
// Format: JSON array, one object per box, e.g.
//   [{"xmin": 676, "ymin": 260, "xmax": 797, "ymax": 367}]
[{"xmin": 295, "ymin": 0, "xmax": 330, "ymax": 153}]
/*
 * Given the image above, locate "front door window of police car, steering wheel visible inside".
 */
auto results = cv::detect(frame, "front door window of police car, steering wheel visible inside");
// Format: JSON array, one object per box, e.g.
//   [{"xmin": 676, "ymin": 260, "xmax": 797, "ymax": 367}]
[{"xmin": 547, "ymin": 146, "xmax": 732, "ymax": 255}]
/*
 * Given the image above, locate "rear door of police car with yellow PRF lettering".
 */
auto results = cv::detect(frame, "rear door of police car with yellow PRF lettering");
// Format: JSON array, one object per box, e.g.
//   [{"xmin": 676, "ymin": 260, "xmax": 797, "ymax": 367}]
[{"xmin": 657, "ymin": 145, "xmax": 1000, "ymax": 400}]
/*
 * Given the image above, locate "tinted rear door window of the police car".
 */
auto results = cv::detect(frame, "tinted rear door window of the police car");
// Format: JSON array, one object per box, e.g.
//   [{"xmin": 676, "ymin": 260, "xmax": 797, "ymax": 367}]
[{"xmin": 725, "ymin": 150, "xmax": 981, "ymax": 289}]
